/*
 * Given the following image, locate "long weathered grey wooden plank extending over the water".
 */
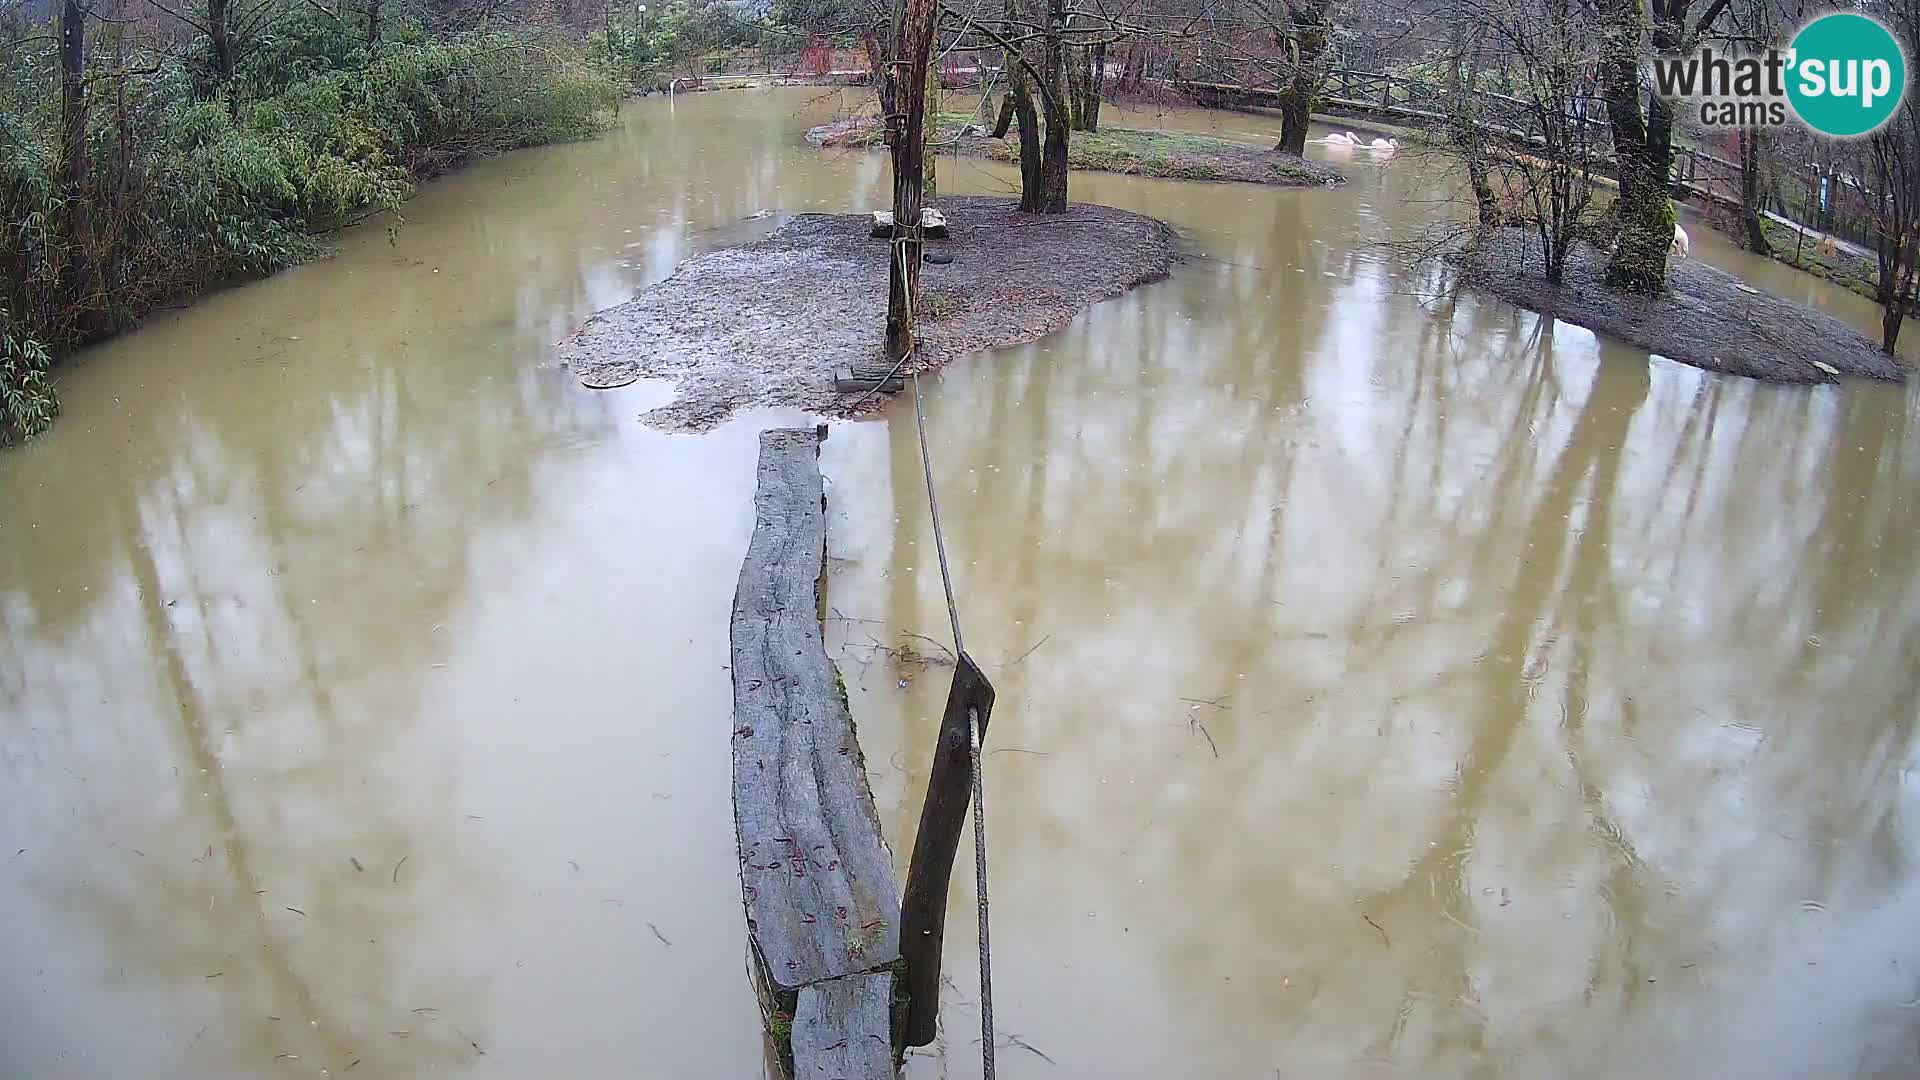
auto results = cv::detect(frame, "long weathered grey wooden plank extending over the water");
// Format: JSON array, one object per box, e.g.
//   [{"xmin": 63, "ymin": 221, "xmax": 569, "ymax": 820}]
[{"xmin": 732, "ymin": 430, "xmax": 900, "ymax": 992}]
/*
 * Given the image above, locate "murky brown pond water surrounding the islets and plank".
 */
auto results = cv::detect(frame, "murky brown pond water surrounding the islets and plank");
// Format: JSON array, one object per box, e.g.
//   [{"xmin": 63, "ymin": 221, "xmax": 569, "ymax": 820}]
[{"xmin": 0, "ymin": 90, "xmax": 1920, "ymax": 1078}]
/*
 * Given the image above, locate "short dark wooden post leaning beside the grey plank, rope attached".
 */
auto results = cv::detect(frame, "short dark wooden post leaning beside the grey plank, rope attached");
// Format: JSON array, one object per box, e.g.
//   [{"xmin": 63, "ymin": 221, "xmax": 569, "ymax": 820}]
[{"xmin": 900, "ymin": 653, "xmax": 993, "ymax": 1045}]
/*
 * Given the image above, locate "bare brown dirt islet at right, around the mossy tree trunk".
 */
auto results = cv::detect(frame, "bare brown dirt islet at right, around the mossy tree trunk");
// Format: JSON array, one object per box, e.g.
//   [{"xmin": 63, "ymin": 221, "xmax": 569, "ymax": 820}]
[{"xmin": 1455, "ymin": 229, "xmax": 1907, "ymax": 382}]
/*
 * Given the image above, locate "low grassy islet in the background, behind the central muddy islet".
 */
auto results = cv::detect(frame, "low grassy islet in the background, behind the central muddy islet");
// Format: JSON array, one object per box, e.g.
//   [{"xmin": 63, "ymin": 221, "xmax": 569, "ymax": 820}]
[{"xmin": 806, "ymin": 113, "xmax": 1338, "ymax": 184}]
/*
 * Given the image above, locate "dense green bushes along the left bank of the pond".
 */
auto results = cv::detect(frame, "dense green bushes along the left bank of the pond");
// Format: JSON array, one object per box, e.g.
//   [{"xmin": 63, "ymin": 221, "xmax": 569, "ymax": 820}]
[{"xmin": 0, "ymin": 6, "xmax": 616, "ymax": 442}]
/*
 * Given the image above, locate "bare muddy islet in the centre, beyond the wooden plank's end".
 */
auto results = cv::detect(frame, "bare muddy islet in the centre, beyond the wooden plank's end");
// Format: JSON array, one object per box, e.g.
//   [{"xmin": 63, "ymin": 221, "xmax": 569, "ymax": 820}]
[{"xmin": 561, "ymin": 198, "xmax": 1175, "ymax": 430}]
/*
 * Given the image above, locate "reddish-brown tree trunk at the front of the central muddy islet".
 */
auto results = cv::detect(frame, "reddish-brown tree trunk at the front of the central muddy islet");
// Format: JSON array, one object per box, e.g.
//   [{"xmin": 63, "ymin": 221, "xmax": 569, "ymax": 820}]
[{"xmin": 887, "ymin": 0, "xmax": 933, "ymax": 361}]
